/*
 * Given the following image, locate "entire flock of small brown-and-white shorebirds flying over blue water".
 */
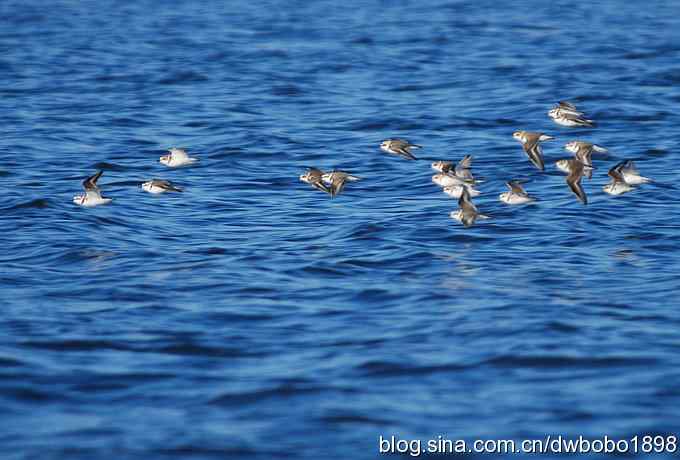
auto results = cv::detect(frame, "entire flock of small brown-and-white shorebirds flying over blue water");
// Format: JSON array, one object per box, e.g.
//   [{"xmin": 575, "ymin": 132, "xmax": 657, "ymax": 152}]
[{"xmin": 73, "ymin": 101, "xmax": 651, "ymax": 227}]
